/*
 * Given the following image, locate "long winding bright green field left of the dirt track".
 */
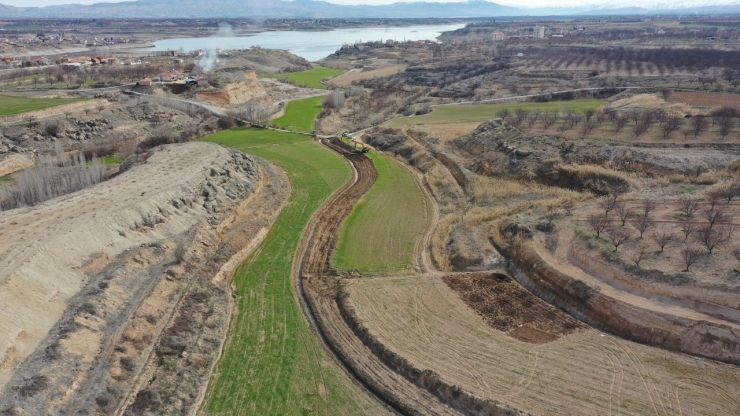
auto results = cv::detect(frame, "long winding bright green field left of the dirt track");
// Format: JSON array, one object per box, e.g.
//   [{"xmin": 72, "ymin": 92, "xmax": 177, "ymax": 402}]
[{"xmin": 200, "ymin": 129, "xmax": 385, "ymax": 415}]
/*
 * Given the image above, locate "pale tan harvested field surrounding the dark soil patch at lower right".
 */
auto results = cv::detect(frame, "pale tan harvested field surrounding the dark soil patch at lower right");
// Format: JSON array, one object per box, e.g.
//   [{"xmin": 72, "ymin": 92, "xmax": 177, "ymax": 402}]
[{"xmin": 347, "ymin": 277, "xmax": 740, "ymax": 415}]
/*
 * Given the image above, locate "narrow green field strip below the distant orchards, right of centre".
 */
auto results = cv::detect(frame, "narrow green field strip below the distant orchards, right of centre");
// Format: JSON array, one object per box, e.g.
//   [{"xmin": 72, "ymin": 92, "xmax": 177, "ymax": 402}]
[{"xmin": 388, "ymin": 99, "xmax": 604, "ymax": 127}]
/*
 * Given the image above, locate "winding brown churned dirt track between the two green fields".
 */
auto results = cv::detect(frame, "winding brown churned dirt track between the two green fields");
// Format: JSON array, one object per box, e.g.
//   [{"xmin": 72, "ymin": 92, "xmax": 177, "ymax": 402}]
[{"xmin": 294, "ymin": 139, "xmax": 459, "ymax": 415}]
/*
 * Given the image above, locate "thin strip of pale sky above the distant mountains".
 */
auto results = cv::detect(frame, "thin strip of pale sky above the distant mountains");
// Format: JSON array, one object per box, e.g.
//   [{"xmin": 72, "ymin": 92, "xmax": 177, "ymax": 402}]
[{"xmin": 0, "ymin": 0, "xmax": 740, "ymax": 9}]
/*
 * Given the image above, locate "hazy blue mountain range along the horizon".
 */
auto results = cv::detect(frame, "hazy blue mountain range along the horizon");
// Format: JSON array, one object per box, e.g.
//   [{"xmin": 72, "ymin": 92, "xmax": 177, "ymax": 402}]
[{"xmin": 0, "ymin": 0, "xmax": 740, "ymax": 19}]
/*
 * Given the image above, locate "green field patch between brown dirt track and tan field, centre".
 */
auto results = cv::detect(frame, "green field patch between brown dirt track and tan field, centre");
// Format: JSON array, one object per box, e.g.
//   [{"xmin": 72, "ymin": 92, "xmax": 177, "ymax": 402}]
[{"xmin": 334, "ymin": 152, "xmax": 432, "ymax": 274}]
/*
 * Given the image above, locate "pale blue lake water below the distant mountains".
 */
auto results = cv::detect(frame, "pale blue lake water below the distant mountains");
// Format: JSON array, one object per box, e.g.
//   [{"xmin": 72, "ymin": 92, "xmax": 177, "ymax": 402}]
[{"xmin": 148, "ymin": 24, "xmax": 465, "ymax": 61}]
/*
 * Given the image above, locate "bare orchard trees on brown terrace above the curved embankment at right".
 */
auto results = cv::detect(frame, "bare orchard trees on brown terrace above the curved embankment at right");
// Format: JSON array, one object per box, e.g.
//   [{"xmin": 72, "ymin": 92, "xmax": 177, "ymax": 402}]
[{"xmin": 586, "ymin": 196, "xmax": 740, "ymax": 271}]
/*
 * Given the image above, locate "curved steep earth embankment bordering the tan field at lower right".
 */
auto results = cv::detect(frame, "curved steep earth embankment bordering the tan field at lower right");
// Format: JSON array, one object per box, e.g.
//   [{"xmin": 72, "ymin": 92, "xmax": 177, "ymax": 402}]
[{"xmin": 496, "ymin": 231, "xmax": 740, "ymax": 364}]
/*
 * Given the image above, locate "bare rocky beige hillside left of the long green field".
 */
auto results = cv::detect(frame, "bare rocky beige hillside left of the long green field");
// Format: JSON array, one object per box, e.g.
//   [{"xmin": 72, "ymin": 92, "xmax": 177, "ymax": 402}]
[{"xmin": 0, "ymin": 142, "xmax": 290, "ymax": 415}]
